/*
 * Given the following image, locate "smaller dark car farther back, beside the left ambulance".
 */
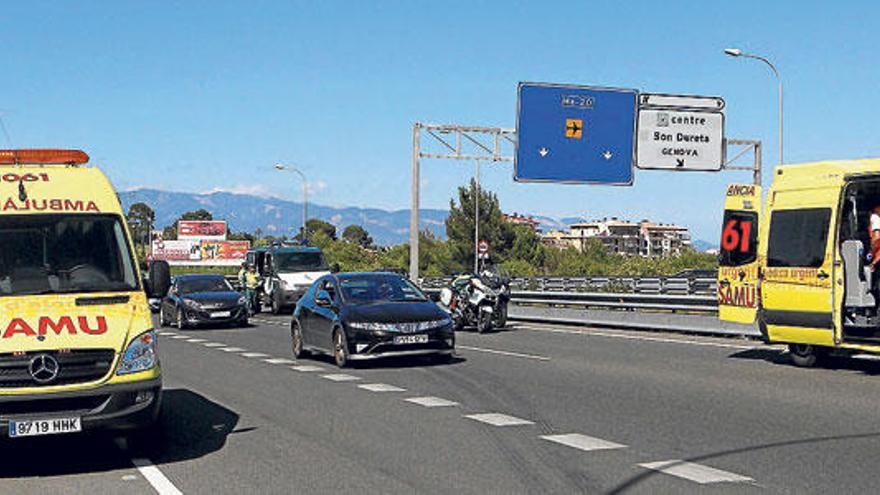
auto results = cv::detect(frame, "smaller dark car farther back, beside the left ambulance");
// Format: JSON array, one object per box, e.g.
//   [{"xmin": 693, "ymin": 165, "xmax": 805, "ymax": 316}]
[{"xmin": 159, "ymin": 275, "xmax": 248, "ymax": 329}]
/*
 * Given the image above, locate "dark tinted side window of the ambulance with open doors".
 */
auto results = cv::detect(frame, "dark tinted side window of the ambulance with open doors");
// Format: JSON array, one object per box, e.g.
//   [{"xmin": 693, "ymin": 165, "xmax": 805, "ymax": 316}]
[{"xmin": 767, "ymin": 208, "xmax": 831, "ymax": 268}]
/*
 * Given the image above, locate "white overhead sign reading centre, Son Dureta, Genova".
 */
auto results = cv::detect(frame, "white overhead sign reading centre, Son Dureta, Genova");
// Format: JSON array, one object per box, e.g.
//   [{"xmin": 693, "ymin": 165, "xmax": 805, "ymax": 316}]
[{"xmin": 636, "ymin": 95, "xmax": 724, "ymax": 171}]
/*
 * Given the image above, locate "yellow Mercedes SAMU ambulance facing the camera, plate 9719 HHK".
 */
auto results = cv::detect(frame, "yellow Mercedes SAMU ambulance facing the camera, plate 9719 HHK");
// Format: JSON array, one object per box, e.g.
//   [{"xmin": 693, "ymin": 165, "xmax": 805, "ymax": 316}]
[{"xmin": 0, "ymin": 149, "xmax": 169, "ymax": 448}]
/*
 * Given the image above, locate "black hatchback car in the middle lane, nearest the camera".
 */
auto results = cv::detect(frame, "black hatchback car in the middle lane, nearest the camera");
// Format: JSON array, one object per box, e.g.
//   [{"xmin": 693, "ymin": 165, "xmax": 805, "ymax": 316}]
[{"xmin": 290, "ymin": 273, "xmax": 455, "ymax": 367}]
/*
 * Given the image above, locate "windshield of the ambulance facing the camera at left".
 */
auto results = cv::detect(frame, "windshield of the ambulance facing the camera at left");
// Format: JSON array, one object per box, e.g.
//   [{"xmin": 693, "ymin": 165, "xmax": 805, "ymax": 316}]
[{"xmin": 0, "ymin": 215, "xmax": 139, "ymax": 296}]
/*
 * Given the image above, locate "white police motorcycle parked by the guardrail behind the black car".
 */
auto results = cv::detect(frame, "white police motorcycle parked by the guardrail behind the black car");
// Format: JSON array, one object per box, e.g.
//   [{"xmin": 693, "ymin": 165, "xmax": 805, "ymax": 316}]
[{"xmin": 440, "ymin": 274, "xmax": 509, "ymax": 333}]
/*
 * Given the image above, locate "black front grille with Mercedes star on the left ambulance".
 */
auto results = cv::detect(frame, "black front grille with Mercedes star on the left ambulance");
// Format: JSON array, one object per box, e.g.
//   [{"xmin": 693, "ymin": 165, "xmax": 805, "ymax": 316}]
[{"xmin": 0, "ymin": 349, "xmax": 114, "ymax": 388}]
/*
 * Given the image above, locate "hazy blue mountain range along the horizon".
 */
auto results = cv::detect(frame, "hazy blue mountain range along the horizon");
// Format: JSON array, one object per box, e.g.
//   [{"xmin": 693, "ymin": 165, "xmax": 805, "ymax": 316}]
[{"xmin": 119, "ymin": 189, "xmax": 712, "ymax": 250}]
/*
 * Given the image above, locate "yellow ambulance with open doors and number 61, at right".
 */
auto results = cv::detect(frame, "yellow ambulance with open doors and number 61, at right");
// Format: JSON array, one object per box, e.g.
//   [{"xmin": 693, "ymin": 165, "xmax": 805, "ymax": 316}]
[{"xmin": 718, "ymin": 159, "xmax": 880, "ymax": 366}]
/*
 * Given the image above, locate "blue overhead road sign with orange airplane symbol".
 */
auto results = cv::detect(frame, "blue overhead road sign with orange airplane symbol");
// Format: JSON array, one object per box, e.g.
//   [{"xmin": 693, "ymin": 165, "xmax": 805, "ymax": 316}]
[{"xmin": 514, "ymin": 83, "xmax": 638, "ymax": 185}]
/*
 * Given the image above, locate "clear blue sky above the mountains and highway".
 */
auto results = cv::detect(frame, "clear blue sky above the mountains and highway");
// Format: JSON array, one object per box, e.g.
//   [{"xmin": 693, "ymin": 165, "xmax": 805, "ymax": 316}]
[{"xmin": 0, "ymin": 1, "xmax": 880, "ymax": 240}]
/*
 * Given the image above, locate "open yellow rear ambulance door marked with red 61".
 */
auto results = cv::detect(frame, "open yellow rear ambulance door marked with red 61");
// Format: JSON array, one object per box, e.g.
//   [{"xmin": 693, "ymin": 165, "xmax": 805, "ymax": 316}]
[{"xmin": 718, "ymin": 184, "xmax": 761, "ymax": 323}]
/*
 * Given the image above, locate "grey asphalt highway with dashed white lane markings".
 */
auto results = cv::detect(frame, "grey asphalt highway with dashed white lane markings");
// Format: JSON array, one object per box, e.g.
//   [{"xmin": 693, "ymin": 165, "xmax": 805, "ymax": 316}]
[{"xmin": 0, "ymin": 316, "xmax": 880, "ymax": 494}]
